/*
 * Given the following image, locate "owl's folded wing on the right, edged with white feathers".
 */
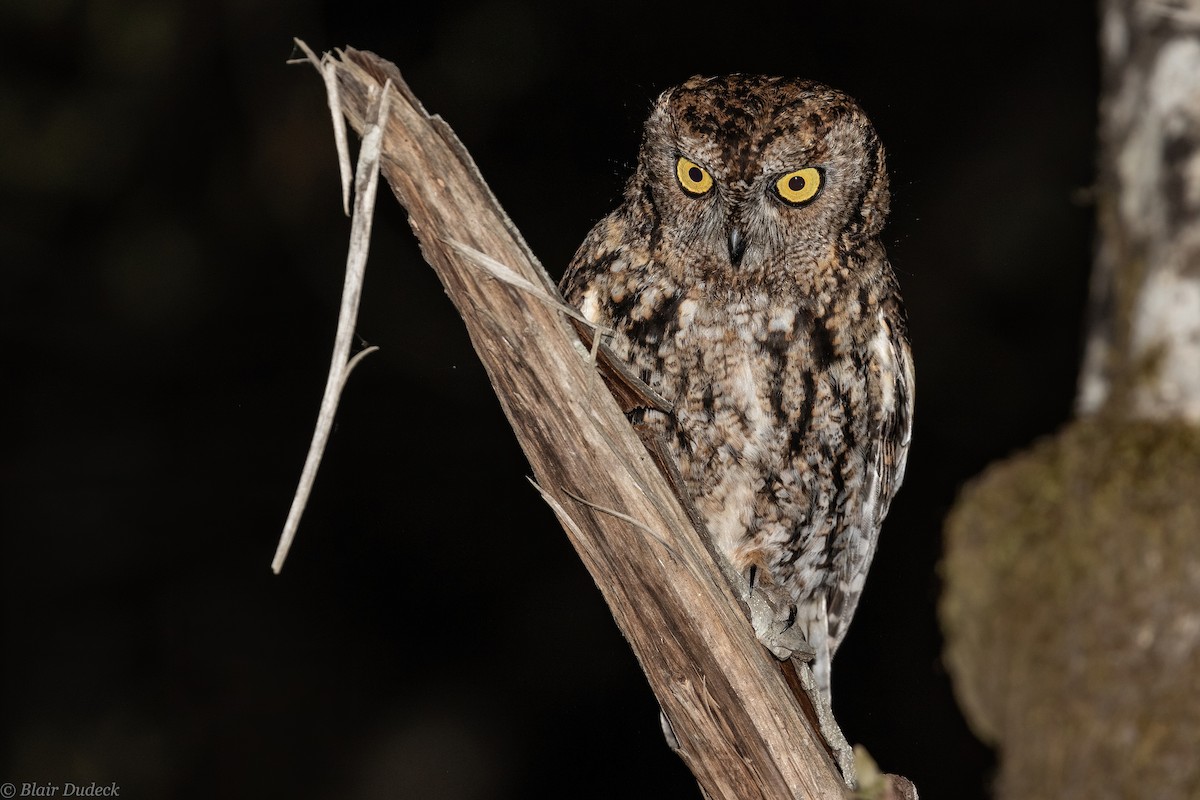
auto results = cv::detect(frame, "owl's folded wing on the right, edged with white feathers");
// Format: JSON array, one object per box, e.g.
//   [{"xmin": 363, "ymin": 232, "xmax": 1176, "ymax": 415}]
[{"xmin": 828, "ymin": 306, "xmax": 913, "ymax": 655}]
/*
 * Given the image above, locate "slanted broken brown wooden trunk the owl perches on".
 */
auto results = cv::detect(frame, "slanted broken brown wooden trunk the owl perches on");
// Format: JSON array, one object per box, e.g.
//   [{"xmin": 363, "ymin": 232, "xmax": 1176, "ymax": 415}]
[{"xmin": 309, "ymin": 50, "xmax": 914, "ymax": 800}]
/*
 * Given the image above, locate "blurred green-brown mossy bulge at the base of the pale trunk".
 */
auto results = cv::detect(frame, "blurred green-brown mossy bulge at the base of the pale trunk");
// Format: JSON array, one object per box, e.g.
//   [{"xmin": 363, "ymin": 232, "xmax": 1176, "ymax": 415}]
[{"xmin": 941, "ymin": 416, "xmax": 1200, "ymax": 798}]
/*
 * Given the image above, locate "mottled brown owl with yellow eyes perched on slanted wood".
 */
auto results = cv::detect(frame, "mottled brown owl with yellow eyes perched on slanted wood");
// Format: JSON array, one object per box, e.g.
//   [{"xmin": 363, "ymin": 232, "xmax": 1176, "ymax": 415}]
[{"xmin": 560, "ymin": 74, "xmax": 913, "ymax": 702}]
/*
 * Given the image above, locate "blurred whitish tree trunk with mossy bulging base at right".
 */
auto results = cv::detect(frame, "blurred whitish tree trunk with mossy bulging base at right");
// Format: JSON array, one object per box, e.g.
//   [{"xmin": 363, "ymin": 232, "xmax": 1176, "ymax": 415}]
[{"xmin": 941, "ymin": 0, "xmax": 1200, "ymax": 800}]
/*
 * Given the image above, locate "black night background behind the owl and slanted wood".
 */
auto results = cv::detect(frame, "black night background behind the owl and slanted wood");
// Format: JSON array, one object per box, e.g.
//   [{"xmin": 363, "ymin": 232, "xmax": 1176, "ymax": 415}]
[{"xmin": 0, "ymin": 0, "xmax": 1098, "ymax": 800}]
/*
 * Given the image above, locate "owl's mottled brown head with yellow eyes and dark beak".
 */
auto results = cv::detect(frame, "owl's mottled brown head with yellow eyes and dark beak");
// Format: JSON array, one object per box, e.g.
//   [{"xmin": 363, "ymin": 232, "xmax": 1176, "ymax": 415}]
[{"xmin": 630, "ymin": 74, "xmax": 888, "ymax": 283}]
